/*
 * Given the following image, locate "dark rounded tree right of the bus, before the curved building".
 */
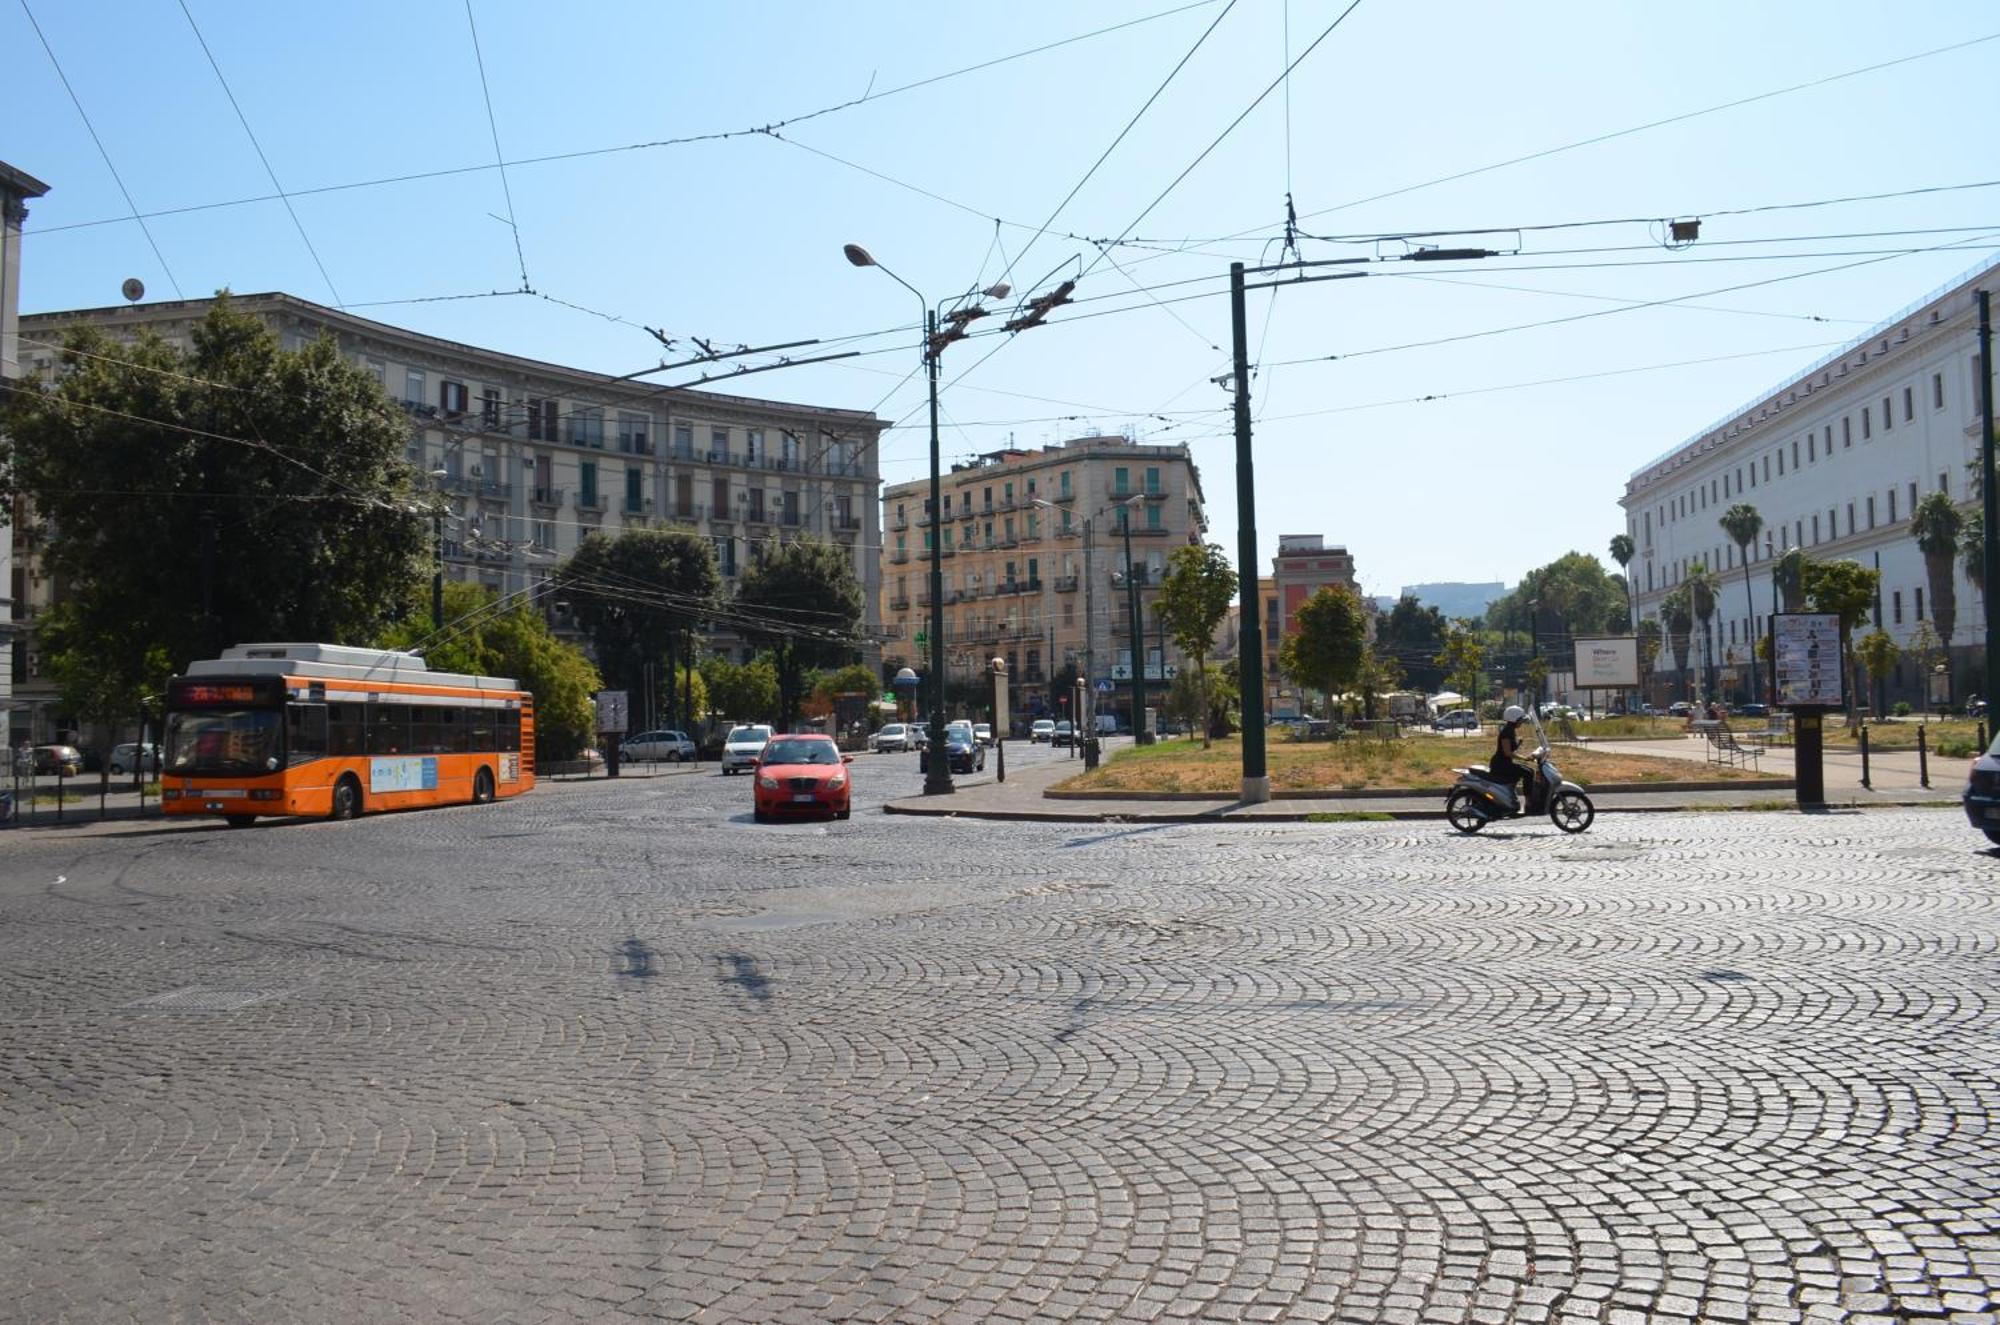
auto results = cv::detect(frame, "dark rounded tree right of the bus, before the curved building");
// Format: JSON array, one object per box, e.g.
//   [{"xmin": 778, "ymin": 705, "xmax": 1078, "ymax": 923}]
[{"xmin": 558, "ymin": 528, "xmax": 722, "ymax": 713}]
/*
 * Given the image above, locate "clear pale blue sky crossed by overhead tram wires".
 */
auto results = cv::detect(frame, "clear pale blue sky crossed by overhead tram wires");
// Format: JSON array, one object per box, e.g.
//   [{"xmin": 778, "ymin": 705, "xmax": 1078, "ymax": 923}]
[{"xmin": 15, "ymin": 0, "xmax": 2000, "ymax": 592}]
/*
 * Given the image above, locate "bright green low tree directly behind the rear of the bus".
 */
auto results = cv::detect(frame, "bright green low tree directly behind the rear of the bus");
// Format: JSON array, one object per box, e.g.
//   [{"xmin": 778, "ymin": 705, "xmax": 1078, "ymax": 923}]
[{"xmin": 374, "ymin": 580, "xmax": 604, "ymax": 761}]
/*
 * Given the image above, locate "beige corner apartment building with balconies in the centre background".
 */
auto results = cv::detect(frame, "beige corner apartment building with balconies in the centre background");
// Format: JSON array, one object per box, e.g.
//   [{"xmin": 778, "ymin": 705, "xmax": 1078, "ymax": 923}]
[{"xmin": 882, "ymin": 436, "xmax": 1208, "ymax": 721}]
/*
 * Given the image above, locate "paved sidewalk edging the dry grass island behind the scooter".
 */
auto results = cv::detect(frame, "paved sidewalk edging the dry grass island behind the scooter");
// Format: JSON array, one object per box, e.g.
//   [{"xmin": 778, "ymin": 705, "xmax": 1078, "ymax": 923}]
[{"xmin": 882, "ymin": 743, "xmax": 1970, "ymax": 823}]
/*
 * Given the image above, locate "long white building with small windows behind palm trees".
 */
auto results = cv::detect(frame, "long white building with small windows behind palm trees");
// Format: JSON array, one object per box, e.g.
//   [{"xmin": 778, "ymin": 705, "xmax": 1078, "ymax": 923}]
[{"xmin": 1620, "ymin": 260, "xmax": 2000, "ymax": 701}]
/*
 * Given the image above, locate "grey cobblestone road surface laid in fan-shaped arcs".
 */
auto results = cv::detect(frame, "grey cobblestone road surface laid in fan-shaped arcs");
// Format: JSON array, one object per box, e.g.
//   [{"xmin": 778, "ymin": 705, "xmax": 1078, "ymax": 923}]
[{"xmin": 0, "ymin": 751, "xmax": 2000, "ymax": 1325}]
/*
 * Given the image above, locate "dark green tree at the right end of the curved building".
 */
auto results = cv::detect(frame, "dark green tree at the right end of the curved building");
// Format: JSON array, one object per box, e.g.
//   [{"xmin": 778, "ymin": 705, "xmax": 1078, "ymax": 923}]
[{"xmin": 736, "ymin": 536, "xmax": 862, "ymax": 727}]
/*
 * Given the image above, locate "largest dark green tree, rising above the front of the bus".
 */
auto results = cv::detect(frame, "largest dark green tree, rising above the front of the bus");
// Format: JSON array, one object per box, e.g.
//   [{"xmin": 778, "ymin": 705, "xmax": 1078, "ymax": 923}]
[{"xmin": 0, "ymin": 298, "xmax": 432, "ymax": 680}]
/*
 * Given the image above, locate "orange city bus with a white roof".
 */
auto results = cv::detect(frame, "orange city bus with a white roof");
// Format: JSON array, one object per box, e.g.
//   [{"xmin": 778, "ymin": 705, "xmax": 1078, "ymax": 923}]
[{"xmin": 160, "ymin": 644, "xmax": 534, "ymax": 829}]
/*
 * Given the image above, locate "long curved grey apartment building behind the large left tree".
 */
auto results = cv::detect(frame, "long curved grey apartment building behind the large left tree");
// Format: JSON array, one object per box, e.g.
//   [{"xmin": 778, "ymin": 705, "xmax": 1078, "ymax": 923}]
[{"xmin": 14, "ymin": 294, "xmax": 884, "ymax": 736}]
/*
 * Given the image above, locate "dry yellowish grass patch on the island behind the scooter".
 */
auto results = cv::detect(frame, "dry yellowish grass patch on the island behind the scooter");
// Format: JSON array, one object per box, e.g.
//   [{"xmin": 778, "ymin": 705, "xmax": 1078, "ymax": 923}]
[{"xmin": 1062, "ymin": 733, "xmax": 1758, "ymax": 797}]
